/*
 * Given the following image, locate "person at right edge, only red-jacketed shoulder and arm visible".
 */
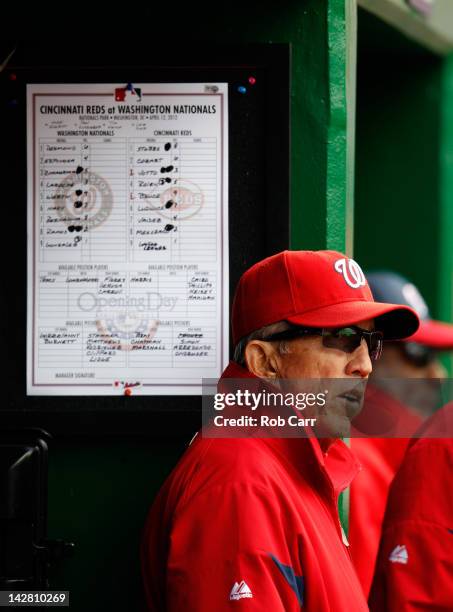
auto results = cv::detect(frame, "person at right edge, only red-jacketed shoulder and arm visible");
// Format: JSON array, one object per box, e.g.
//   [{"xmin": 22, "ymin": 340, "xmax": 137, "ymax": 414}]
[{"xmin": 370, "ymin": 403, "xmax": 453, "ymax": 612}]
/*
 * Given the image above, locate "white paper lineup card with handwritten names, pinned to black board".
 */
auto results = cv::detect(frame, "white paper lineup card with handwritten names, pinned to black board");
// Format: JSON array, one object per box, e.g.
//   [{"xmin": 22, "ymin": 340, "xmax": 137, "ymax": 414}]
[{"xmin": 27, "ymin": 83, "xmax": 229, "ymax": 395}]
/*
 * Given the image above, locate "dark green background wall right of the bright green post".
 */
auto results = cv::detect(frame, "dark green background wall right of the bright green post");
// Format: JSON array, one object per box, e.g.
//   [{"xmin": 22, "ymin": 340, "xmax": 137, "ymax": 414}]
[{"xmin": 355, "ymin": 12, "xmax": 443, "ymax": 313}]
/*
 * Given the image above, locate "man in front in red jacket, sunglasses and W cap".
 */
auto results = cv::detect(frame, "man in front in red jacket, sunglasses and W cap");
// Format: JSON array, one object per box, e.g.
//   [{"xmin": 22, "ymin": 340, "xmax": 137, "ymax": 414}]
[{"xmin": 142, "ymin": 251, "xmax": 418, "ymax": 612}]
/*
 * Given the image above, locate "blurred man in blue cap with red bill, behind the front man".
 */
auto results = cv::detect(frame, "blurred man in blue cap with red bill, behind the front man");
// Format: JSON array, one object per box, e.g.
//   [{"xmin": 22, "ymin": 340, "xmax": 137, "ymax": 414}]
[{"xmin": 348, "ymin": 271, "xmax": 453, "ymax": 597}]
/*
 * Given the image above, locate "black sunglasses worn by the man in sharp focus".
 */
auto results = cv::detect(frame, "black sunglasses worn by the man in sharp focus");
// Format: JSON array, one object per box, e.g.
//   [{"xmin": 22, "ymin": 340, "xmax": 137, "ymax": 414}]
[{"xmin": 262, "ymin": 325, "xmax": 384, "ymax": 361}]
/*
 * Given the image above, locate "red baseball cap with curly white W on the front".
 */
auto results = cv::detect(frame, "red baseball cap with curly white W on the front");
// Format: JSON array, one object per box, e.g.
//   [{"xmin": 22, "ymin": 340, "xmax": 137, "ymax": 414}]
[{"xmin": 231, "ymin": 251, "xmax": 419, "ymax": 344}]
